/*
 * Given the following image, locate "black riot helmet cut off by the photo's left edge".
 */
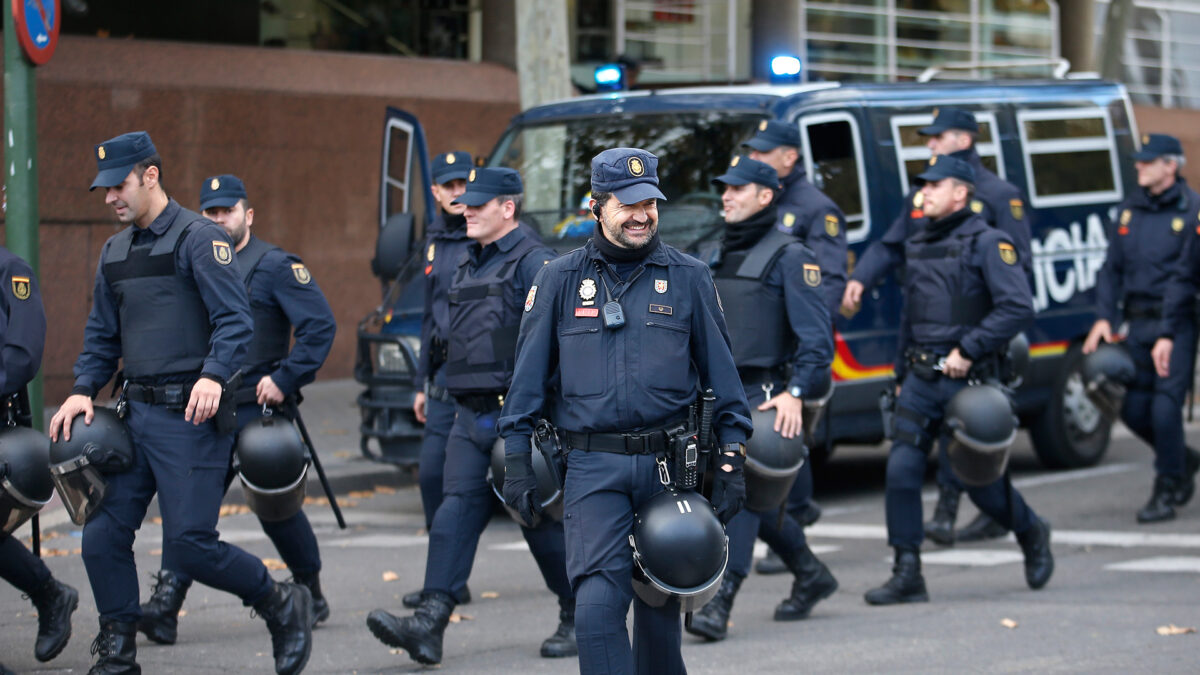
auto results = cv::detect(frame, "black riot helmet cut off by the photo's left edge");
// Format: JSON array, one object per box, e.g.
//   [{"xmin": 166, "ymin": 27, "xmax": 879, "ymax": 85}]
[{"xmin": 0, "ymin": 426, "xmax": 54, "ymax": 534}]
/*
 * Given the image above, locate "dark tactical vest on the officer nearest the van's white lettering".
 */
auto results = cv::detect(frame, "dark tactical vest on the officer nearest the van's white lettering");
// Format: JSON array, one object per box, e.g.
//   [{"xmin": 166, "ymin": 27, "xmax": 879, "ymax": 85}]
[{"xmin": 905, "ymin": 221, "xmax": 992, "ymax": 347}]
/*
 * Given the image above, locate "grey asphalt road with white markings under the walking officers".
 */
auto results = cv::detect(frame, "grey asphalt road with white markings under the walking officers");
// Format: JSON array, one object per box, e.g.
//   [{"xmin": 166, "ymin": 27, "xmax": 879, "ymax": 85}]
[{"xmin": 0, "ymin": 374, "xmax": 1200, "ymax": 674}]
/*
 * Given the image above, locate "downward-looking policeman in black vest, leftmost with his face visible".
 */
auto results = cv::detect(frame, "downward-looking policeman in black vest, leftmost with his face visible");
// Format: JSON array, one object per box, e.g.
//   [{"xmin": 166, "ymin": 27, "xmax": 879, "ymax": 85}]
[{"xmin": 50, "ymin": 131, "xmax": 312, "ymax": 674}]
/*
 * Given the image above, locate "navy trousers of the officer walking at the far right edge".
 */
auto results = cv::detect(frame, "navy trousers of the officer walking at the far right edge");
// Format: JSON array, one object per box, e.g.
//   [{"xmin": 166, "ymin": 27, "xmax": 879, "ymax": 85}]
[{"xmin": 1121, "ymin": 318, "xmax": 1195, "ymax": 477}]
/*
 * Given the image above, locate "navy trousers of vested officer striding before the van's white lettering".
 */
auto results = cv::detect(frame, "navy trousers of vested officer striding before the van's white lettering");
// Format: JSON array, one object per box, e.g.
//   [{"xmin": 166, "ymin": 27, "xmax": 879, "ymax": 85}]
[{"xmin": 886, "ymin": 374, "xmax": 1036, "ymax": 549}]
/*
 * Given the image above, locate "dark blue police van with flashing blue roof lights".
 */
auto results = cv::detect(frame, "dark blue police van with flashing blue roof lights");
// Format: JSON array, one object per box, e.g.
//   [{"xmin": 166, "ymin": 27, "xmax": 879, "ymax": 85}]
[{"xmin": 356, "ymin": 73, "xmax": 1138, "ymax": 467}]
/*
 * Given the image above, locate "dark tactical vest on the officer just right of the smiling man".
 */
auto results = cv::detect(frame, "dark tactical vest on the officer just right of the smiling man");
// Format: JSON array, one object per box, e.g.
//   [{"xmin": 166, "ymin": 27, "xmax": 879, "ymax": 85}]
[{"xmin": 713, "ymin": 229, "xmax": 796, "ymax": 368}]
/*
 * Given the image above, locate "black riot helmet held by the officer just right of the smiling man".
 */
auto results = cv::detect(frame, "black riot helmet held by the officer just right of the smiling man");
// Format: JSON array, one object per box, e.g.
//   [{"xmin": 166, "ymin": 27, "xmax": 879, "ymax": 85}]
[{"xmin": 745, "ymin": 410, "xmax": 809, "ymax": 510}]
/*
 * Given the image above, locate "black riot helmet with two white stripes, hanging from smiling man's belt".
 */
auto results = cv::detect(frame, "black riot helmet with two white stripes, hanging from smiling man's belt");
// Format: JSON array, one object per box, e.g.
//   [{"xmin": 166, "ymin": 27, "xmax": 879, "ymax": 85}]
[{"xmin": 629, "ymin": 488, "xmax": 730, "ymax": 613}]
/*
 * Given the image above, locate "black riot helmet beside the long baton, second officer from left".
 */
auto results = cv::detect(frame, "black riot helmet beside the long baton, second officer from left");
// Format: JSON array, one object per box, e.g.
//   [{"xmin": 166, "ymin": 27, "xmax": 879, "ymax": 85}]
[{"xmin": 236, "ymin": 408, "xmax": 308, "ymax": 521}]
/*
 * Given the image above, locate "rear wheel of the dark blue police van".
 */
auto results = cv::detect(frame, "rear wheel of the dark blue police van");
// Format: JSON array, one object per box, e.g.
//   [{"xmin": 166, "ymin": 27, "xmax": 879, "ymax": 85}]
[{"xmin": 1030, "ymin": 344, "xmax": 1112, "ymax": 468}]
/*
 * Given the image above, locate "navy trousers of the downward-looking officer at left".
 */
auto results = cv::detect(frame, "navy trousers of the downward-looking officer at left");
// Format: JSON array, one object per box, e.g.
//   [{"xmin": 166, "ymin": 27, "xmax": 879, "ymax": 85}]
[{"xmin": 83, "ymin": 402, "xmax": 274, "ymax": 622}]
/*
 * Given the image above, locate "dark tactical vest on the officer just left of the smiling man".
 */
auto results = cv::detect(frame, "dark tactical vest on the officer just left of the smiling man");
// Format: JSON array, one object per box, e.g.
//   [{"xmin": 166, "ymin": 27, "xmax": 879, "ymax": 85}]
[{"xmin": 445, "ymin": 237, "xmax": 539, "ymax": 395}]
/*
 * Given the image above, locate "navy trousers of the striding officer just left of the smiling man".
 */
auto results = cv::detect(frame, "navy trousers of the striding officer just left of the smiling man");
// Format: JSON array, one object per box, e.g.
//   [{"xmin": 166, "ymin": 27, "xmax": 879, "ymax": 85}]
[{"xmin": 425, "ymin": 406, "xmax": 575, "ymax": 607}]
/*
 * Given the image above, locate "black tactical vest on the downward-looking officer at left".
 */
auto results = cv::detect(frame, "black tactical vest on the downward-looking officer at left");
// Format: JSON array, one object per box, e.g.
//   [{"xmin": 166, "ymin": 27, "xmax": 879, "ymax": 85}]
[{"xmin": 103, "ymin": 209, "xmax": 212, "ymax": 380}]
